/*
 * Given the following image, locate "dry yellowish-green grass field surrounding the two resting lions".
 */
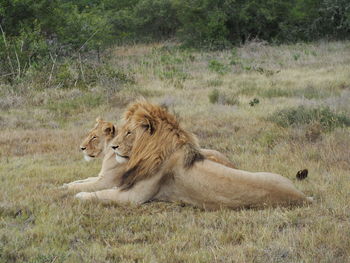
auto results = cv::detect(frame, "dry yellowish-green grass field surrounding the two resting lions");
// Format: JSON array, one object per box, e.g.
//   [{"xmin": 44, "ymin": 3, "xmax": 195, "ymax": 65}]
[{"xmin": 0, "ymin": 42, "xmax": 350, "ymax": 263}]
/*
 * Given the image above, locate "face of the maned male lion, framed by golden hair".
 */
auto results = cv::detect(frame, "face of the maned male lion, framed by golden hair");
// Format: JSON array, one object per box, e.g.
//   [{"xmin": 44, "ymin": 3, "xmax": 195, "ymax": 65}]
[{"xmin": 111, "ymin": 124, "xmax": 136, "ymax": 163}]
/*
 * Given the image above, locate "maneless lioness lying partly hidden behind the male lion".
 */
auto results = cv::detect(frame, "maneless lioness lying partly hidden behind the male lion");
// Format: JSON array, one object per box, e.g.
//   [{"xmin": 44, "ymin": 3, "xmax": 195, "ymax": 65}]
[{"xmin": 63, "ymin": 118, "xmax": 234, "ymax": 192}]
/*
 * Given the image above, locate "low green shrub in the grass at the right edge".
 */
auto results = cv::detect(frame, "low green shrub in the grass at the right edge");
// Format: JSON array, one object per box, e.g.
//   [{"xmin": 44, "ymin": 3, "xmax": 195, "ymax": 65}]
[{"xmin": 269, "ymin": 106, "xmax": 350, "ymax": 131}]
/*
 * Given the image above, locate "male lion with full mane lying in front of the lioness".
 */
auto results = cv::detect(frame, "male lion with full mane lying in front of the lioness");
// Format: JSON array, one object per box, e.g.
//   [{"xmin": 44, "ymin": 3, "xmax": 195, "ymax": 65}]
[{"xmin": 76, "ymin": 101, "xmax": 312, "ymax": 210}]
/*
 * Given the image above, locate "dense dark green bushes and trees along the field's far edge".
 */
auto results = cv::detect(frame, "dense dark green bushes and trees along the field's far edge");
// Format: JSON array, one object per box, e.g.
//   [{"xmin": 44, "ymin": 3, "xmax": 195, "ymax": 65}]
[{"xmin": 0, "ymin": 0, "xmax": 350, "ymax": 82}]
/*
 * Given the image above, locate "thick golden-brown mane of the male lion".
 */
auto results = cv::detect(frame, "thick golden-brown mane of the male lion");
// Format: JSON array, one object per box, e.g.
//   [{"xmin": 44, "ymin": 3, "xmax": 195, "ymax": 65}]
[{"xmin": 120, "ymin": 101, "xmax": 204, "ymax": 189}]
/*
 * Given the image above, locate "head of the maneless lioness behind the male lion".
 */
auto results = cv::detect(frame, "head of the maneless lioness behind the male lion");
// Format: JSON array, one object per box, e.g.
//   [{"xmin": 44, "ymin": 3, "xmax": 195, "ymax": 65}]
[{"xmin": 80, "ymin": 118, "xmax": 116, "ymax": 161}]
